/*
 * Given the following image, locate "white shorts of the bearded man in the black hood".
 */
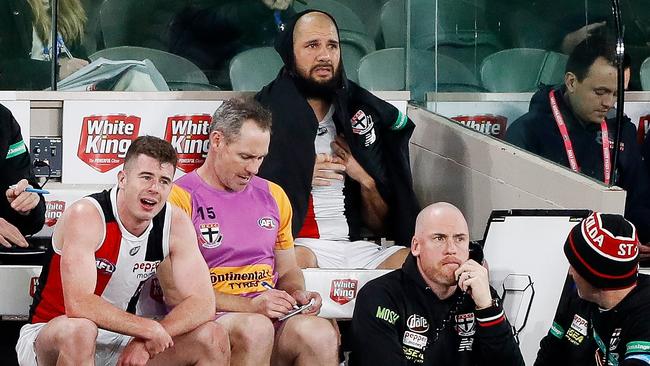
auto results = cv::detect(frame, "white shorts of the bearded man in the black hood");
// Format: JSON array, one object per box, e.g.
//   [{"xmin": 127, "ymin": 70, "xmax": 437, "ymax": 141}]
[{"xmin": 294, "ymin": 238, "xmax": 405, "ymax": 269}]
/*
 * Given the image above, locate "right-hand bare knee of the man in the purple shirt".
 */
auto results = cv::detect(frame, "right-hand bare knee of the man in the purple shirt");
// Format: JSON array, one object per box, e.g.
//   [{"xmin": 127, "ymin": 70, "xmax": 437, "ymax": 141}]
[{"xmin": 271, "ymin": 315, "xmax": 339, "ymax": 366}]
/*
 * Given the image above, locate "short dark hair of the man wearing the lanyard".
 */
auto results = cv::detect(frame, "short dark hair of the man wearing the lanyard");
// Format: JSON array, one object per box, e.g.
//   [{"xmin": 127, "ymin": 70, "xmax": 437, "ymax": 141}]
[{"xmin": 566, "ymin": 34, "xmax": 616, "ymax": 82}]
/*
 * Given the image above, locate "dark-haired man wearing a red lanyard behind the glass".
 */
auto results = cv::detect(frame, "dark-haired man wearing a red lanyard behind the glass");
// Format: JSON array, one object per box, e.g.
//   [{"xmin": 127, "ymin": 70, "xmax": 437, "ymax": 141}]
[{"xmin": 506, "ymin": 35, "xmax": 650, "ymax": 259}]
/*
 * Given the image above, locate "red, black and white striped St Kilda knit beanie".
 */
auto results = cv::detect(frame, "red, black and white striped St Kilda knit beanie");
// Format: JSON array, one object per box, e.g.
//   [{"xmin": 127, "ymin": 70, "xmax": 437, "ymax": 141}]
[{"xmin": 564, "ymin": 212, "xmax": 639, "ymax": 289}]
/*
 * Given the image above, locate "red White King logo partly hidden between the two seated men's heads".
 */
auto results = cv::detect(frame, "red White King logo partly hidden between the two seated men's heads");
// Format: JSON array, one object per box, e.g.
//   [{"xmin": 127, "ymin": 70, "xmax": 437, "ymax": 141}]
[{"xmin": 165, "ymin": 114, "xmax": 212, "ymax": 173}]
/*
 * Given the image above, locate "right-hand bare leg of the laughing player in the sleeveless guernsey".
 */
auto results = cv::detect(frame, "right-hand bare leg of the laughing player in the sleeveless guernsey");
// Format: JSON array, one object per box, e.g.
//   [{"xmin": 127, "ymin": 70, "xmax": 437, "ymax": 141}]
[{"xmin": 147, "ymin": 322, "xmax": 230, "ymax": 366}]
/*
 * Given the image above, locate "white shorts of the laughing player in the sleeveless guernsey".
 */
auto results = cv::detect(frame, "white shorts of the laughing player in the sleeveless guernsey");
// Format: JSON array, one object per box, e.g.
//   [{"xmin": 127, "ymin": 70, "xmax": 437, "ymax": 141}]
[{"xmin": 16, "ymin": 323, "xmax": 132, "ymax": 366}]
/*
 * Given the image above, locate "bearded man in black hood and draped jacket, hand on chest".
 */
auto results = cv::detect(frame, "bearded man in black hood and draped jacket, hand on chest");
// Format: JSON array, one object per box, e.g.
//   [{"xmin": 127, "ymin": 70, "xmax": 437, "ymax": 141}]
[{"xmin": 255, "ymin": 10, "xmax": 419, "ymax": 269}]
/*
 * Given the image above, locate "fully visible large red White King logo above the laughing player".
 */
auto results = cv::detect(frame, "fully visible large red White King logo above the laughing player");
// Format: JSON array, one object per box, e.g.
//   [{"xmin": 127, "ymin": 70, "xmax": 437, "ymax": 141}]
[{"xmin": 77, "ymin": 114, "xmax": 140, "ymax": 173}]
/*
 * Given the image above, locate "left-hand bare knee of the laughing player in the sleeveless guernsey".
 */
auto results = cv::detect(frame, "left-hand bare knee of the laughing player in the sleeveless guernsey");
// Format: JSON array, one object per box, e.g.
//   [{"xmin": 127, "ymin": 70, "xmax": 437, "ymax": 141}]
[{"xmin": 34, "ymin": 315, "xmax": 97, "ymax": 366}]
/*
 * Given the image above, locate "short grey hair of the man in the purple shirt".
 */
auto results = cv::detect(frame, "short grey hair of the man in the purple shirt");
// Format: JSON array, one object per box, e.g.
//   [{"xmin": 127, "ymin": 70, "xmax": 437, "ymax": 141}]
[{"xmin": 210, "ymin": 98, "xmax": 271, "ymax": 143}]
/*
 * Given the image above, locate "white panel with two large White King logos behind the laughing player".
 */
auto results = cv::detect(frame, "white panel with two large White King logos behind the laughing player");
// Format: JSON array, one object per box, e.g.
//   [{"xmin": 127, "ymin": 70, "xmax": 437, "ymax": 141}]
[{"xmin": 62, "ymin": 100, "xmax": 221, "ymax": 184}]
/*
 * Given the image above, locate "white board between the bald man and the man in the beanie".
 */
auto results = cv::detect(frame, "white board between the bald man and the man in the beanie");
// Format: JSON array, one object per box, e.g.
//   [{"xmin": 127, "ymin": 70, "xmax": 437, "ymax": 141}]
[{"xmin": 485, "ymin": 212, "xmax": 578, "ymax": 365}]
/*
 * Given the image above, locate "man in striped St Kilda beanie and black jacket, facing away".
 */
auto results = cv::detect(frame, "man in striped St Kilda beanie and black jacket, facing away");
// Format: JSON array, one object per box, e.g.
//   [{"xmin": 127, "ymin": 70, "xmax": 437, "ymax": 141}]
[{"xmin": 535, "ymin": 212, "xmax": 650, "ymax": 366}]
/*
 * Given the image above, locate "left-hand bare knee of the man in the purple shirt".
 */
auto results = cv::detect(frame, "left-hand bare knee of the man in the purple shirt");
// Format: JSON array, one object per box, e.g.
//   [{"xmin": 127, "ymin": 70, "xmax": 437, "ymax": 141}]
[{"xmin": 217, "ymin": 313, "xmax": 275, "ymax": 366}]
